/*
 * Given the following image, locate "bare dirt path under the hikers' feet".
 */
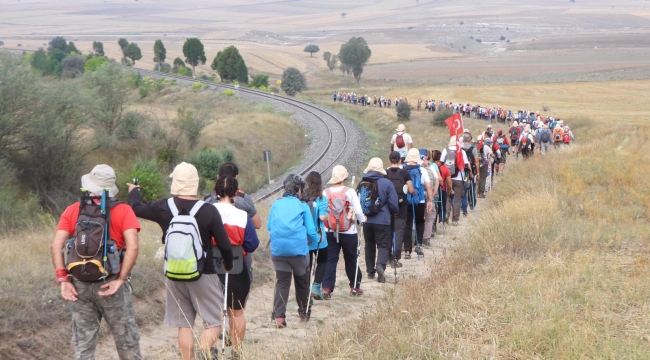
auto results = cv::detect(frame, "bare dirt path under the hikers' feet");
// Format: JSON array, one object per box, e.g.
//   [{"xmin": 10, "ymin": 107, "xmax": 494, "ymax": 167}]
[{"xmin": 98, "ymin": 204, "xmax": 480, "ymax": 360}]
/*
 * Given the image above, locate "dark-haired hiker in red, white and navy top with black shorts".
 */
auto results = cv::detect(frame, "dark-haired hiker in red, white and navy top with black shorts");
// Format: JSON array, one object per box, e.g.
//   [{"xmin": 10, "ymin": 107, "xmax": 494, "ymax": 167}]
[{"xmin": 213, "ymin": 176, "xmax": 260, "ymax": 356}]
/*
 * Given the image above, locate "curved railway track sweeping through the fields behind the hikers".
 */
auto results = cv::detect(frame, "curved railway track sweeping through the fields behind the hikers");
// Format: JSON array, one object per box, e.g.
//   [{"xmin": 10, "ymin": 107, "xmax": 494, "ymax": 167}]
[{"xmin": 135, "ymin": 69, "xmax": 363, "ymax": 202}]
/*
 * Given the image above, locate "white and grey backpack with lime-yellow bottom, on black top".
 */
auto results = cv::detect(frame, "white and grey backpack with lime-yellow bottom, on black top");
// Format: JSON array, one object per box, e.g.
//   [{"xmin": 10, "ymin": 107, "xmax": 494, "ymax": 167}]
[{"xmin": 163, "ymin": 198, "xmax": 206, "ymax": 281}]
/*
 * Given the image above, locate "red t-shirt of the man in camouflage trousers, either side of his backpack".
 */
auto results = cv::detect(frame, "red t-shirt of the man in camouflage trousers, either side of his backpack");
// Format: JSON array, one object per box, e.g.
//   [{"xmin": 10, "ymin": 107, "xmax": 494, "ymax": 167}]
[{"xmin": 56, "ymin": 202, "xmax": 140, "ymax": 249}]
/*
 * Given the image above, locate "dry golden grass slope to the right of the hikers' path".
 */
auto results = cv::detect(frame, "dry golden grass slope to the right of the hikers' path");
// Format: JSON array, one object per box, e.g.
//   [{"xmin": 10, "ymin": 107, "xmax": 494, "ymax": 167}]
[{"xmin": 298, "ymin": 82, "xmax": 650, "ymax": 359}]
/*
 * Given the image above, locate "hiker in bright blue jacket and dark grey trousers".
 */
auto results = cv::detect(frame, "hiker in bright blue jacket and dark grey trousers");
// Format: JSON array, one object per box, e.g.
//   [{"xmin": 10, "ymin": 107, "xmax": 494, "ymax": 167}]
[{"xmin": 266, "ymin": 174, "xmax": 320, "ymax": 329}]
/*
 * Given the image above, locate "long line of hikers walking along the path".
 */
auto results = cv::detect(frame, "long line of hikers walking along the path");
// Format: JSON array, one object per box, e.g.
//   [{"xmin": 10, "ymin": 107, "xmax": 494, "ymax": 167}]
[{"xmin": 51, "ymin": 113, "xmax": 574, "ymax": 360}]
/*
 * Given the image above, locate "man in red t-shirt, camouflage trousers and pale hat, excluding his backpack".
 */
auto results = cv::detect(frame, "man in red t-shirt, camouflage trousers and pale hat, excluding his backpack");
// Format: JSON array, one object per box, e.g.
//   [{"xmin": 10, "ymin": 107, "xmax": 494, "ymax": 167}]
[{"xmin": 50, "ymin": 165, "xmax": 142, "ymax": 360}]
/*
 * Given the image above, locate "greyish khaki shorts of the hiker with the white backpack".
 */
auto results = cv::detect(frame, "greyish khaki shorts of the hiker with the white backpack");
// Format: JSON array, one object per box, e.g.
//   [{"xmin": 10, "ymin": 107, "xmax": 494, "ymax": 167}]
[{"xmin": 165, "ymin": 274, "xmax": 223, "ymax": 329}]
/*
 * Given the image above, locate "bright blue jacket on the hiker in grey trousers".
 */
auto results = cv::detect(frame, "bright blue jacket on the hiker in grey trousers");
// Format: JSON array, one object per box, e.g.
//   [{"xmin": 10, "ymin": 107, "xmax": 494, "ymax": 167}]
[{"xmin": 266, "ymin": 195, "xmax": 320, "ymax": 256}]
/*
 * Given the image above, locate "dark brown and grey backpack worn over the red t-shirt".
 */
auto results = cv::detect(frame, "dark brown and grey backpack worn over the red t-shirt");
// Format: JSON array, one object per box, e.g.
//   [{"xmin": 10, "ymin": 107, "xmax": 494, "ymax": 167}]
[{"xmin": 64, "ymin": 191, "xmax": 122, "ymax": 282}]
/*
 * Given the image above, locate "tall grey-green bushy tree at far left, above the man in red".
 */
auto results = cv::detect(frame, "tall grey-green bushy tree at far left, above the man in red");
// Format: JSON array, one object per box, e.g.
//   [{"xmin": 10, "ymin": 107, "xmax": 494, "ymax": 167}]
[{"xmin": 84, "ymin": 63, "xmax": 130, "ymax": 136}]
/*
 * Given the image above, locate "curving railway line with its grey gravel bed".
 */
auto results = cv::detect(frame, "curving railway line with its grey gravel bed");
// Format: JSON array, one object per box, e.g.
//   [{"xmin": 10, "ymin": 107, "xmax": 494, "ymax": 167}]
[{"xmin": 135, "ymin": 69, "xmax": 368, "ymax": 202}]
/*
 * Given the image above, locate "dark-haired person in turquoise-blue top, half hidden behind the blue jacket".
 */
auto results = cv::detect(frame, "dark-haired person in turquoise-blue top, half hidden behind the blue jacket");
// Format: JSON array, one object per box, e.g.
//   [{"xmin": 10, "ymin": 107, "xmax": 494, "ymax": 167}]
[{"xmin": 301, "ymin": 171, "xmax": 327, "ymax": 300}]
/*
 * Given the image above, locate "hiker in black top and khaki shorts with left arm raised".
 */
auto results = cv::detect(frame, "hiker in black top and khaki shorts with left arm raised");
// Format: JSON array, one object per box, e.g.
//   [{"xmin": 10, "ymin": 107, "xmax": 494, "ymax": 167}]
[{"xmin": 127, "ymin": 162, "xmax": 233, "ymax": 360}]
